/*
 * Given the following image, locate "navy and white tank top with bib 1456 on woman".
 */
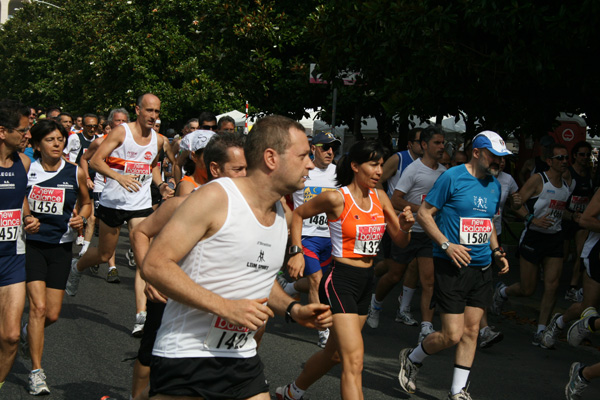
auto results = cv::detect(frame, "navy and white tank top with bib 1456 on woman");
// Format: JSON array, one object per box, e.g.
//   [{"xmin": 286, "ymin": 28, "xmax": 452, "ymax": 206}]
[{"xmin": 27, "ymin": 160, "xmax": 79, "ymax": 244}]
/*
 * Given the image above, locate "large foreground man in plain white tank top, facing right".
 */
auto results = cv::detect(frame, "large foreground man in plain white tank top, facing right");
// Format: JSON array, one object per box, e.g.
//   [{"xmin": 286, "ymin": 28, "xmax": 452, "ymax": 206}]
[{"xmin": 142, "ymin": 116, "xmax": 332, "ymax": 400}]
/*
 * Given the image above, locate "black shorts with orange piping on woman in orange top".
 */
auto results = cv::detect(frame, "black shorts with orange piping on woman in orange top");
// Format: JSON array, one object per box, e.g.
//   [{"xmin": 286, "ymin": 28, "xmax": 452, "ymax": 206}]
[{"xmin": 319, "ymin": 262, "xmax": 374, "ymax": 315}]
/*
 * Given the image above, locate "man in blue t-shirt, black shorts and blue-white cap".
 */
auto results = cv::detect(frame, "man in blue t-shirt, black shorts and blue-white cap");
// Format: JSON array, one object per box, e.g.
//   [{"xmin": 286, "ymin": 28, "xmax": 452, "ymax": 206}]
[{"xmin": 398, "ymin": 131, "xmax": 511, "ymax": 400}]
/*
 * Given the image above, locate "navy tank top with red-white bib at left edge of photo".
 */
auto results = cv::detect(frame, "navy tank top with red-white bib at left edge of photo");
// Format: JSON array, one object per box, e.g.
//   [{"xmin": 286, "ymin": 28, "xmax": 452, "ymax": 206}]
[{"xmin": 0, "ymin": 152, "xmax": 27, "ymax": 256}]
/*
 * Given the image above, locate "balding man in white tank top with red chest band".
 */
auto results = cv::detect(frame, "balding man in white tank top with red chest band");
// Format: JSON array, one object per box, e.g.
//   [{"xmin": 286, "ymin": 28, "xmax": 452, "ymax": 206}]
[{"xmin": 66, "ymin": 93, "xmax": 173, "ymax": 334}]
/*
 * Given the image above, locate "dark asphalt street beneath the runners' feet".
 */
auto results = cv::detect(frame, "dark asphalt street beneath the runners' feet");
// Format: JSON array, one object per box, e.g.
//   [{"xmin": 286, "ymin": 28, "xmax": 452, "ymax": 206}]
[{"xmin": 0, "ymin": 229, "xmax": 600, "ymax": 400}]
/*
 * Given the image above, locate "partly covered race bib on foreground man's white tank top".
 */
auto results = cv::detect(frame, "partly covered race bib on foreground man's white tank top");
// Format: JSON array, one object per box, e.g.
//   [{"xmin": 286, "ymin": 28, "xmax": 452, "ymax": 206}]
[{"xmin": 204, "ymin": 315, "xmax": 256, "ymax": 351}]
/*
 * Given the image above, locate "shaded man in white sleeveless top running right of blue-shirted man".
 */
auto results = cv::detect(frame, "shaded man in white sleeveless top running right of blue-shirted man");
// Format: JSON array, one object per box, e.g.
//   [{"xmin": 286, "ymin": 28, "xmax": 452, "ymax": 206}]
[{"xmin": 492, "ymin": 144, "xmax": 573, "ymax": 349}]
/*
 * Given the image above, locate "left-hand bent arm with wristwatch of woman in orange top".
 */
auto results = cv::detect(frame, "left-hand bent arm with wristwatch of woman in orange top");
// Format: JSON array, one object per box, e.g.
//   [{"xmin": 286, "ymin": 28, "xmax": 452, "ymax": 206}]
[{"xmin": 288, "ymin": 190, "xmax": 344, "ymax": 279}]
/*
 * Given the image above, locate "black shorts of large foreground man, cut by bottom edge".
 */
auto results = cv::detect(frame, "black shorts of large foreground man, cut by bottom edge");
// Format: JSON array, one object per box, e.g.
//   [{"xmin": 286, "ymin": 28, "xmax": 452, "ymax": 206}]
[{"xmin": 150, "ymin": 356, "xmax": 269, "ymax": 400}]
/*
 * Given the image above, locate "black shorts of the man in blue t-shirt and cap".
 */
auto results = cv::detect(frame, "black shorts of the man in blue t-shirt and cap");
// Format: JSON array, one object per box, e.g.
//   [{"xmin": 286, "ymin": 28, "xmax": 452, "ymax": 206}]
[{"xmin": 430, "ymin": 257, "xmax": 492, "ymax": 314}]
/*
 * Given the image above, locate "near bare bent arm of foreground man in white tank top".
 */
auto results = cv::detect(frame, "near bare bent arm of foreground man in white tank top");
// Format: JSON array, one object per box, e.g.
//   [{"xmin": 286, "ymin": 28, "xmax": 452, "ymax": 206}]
[{"xmin": 141, "ymin": 184, "xmax": 273, "ymax": 330}]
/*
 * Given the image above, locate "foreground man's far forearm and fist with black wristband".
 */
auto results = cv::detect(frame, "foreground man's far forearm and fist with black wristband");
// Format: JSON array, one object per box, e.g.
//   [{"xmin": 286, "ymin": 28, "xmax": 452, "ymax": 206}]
[{"xmin": 269, "ymin": 280, "xmax": 333, "ymax": 330}]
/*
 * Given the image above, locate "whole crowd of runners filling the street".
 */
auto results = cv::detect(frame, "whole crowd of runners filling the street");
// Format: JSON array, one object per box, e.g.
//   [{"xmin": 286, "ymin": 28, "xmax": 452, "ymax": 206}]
[{"xmin": 0, "ymin": 93, "xmax": 600, "ymax": 400}]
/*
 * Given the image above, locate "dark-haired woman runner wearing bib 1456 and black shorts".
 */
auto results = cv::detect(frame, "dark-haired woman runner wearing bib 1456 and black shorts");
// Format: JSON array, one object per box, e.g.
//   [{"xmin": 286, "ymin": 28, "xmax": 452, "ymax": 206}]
[{"xmin": 21, "ymin": 119, "xmax": 91, "ymax": 395}]
